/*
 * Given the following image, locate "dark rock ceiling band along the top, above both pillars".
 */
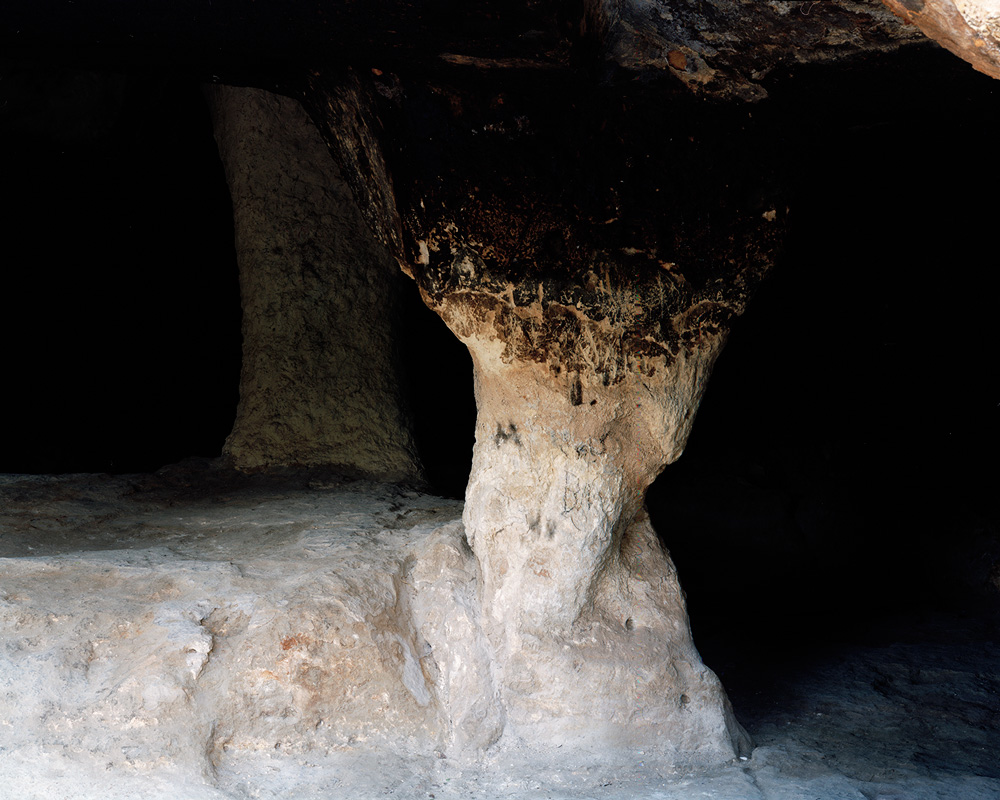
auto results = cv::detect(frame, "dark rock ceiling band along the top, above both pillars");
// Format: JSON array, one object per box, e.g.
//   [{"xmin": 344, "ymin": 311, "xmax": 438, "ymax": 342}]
[{"xmin": 0, "ymin": 0, "xmax": 956, "ymax": 91}]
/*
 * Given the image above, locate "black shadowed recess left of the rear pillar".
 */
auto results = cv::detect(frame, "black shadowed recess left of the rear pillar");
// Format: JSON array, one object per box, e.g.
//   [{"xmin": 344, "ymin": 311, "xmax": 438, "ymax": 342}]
[{"xmin": 0, "ymin": 66, "xmax": 240, "ymax": 472}]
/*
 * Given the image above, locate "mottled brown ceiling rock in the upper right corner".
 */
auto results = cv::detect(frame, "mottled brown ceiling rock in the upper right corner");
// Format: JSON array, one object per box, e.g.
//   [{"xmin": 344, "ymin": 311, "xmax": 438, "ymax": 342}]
[{"xmin": 588, "ymin": 0, "xmax": 1000, "ymax": 101}]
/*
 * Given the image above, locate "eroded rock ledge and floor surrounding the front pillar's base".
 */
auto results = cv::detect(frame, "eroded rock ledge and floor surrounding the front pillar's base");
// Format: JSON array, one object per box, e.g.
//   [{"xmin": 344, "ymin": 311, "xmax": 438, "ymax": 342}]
[{"xmin": 0, "ymin": 467, "xmax": 1000, "ymax": 800}]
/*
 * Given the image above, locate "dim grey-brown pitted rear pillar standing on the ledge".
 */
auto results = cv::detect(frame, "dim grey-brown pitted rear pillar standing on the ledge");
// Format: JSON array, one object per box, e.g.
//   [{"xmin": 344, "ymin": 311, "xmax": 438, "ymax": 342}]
[{"xmin": 208, "ymin": 86, "xmax": 420, "ymax": 479}]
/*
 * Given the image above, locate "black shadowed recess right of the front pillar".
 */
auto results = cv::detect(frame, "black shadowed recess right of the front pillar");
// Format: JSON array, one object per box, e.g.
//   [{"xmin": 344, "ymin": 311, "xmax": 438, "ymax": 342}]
[{"xmin": 648, "ymin": 51, "xmax": 1000, "ymax": 664}]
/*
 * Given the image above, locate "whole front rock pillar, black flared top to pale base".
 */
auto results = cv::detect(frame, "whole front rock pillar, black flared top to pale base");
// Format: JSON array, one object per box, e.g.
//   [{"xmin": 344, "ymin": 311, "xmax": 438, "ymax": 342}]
[{"xmin": 300, "ymin": 71, "xmax": 784, "ymax": 763}]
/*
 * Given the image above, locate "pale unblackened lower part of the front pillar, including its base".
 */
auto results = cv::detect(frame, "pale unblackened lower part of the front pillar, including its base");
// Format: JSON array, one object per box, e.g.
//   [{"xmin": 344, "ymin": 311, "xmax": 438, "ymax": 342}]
[{"xmin": 432, "ymin": 284, "xmax": 750, "ymax": 762}]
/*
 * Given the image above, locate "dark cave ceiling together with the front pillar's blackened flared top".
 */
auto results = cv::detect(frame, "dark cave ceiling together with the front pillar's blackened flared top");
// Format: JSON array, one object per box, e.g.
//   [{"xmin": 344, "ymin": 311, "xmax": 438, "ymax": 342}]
[{"xmin": 0, "ymin": 0, "xmax": 995, "ymax": 358}]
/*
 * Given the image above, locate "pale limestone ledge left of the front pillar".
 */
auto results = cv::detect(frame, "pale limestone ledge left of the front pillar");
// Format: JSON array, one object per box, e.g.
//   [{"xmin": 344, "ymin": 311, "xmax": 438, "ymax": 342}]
[{"xmin": 0, "ymin": 466, "xmax": 456, "ymax": 798}]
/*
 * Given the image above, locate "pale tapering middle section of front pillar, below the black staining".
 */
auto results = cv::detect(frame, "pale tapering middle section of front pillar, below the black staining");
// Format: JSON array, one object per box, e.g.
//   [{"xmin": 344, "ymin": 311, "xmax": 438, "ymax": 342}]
[{"xmin": 464, "ymin": 338, "xmax": 718, "ymax": 636}]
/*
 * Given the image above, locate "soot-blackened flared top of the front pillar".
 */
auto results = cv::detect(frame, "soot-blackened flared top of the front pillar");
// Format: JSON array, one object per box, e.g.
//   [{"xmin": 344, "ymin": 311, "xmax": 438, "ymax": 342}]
[{"xmin": 306, "ymin": 69, "xmax": 786, "ymax": 372}]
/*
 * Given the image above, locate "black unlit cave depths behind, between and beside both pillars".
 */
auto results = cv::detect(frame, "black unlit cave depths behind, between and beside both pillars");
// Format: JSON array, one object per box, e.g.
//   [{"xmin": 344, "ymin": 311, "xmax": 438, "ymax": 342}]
[{"xmin": 0, "ymin": 1, "xmax": 1000, "ymax": 792}]
